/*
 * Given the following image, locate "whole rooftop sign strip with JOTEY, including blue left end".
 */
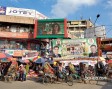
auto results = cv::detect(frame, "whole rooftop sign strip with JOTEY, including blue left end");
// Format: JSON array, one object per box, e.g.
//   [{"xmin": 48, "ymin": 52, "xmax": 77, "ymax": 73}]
[{"xmin": 0, "ymin": 6, "xmax": 47, "ymax": 19}]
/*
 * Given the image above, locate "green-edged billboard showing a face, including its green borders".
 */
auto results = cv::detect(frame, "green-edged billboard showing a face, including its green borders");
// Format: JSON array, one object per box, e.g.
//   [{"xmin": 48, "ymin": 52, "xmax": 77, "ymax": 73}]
[{"xmin": 37, "ymin": 19, "xmax": 67, "ymax": 38}]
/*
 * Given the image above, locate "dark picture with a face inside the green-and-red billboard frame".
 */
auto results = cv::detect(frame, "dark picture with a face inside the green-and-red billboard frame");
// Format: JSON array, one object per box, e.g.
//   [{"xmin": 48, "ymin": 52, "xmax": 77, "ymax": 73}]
[{"xmin": 37, "ymin": 22, "xmax": 64, "ymax": 35}]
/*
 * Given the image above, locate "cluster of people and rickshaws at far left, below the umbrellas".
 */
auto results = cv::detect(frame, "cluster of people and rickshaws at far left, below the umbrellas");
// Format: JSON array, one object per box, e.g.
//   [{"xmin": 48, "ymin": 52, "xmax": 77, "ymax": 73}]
[{"xmin": 0, "ymin": 62, "xmax": 27, "ymax": 81}]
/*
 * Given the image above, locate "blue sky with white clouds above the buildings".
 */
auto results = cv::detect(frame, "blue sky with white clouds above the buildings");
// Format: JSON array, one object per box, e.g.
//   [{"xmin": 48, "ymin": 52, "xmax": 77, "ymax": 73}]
[{"xmin": 0, "ymin": 0, "xmax": 112, "ymax": 38}]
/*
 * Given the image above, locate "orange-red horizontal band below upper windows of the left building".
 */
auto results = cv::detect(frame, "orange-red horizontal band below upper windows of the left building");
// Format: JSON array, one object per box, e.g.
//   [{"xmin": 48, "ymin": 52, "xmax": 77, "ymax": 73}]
[{"xmin": 0, "ymin": 32, "xmax": 33, "ymax": 38}]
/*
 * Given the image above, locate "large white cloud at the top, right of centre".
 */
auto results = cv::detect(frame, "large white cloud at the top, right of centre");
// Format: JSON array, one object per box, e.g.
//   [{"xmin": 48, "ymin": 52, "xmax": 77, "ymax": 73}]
[{"xmin": 51, "ymin": 0, "xmax": 98, "ymax": 17}]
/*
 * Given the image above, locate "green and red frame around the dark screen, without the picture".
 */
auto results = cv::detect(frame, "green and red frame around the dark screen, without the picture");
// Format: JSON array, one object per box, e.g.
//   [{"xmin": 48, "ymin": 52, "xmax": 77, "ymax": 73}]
[{"xmin": 34, "ymin": 19, "xmax": 68, "ymax": 39}]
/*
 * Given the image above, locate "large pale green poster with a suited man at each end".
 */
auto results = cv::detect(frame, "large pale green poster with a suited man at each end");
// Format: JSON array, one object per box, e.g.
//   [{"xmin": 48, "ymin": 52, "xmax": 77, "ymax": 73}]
[{"xmin": 53, "ymin": 38, "xmax": 98, "ymax": 58}]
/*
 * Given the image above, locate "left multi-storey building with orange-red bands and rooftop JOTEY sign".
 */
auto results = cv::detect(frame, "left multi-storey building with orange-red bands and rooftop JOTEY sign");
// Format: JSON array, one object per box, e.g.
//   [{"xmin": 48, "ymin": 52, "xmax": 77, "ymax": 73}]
[{"xmin": 0, "ymin": 7, "xmax": 47, "ymax": 50}]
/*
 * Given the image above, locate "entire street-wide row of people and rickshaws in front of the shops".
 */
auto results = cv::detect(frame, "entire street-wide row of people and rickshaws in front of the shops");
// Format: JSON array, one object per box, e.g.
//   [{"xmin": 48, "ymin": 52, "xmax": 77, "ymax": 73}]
[{"xmin": 0, "ymin": 57, "xmax": 112, "ymax": 81}]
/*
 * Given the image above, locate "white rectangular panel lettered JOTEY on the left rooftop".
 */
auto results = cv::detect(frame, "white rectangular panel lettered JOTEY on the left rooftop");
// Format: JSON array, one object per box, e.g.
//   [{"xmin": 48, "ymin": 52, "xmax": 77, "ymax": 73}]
[{"xmin": 6, "ymin": 7, "xmax": 35, "ymax": 18}]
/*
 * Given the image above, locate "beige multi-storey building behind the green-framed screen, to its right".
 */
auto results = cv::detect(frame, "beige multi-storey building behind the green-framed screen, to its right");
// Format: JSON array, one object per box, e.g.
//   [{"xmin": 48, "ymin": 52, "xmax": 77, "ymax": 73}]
[{"xmin": 67, "ymin": 20, "xmax": 94, "ymax": 38}]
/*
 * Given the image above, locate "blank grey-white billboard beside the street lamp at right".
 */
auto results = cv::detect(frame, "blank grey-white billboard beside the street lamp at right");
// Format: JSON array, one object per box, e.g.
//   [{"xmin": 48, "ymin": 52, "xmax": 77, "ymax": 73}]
[{"xmin": 84, "ymin": 26, "xmax": 106, "ymax": 38}]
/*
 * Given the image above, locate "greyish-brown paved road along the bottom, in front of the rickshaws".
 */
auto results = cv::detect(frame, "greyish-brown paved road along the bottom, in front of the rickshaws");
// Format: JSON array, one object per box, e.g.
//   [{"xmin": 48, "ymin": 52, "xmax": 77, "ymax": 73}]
[{"xmin": 0, "ymin": 80, "xmax": 112, "ymax": 89}]
